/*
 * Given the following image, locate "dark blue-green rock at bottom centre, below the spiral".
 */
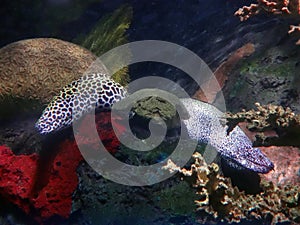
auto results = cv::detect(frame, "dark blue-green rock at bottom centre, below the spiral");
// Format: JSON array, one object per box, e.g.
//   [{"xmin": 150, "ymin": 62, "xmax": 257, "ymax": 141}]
[{"xmin": 72, "ymin": 163, "xmax": 197, "ymax": 225}]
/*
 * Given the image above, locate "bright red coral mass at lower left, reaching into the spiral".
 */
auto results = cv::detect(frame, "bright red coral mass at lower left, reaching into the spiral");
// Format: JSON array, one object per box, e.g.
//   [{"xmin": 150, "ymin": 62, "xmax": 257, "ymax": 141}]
[{"xmin": 0, "ymin": 112, "xmax": 122, "ymax": 223}]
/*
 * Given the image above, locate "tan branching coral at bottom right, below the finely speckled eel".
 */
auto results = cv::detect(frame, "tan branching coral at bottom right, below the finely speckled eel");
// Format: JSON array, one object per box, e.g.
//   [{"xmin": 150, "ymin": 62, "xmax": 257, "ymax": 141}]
[{"xmin": 164, "ymin": 153, "xmax": 300, "ymax": 224}]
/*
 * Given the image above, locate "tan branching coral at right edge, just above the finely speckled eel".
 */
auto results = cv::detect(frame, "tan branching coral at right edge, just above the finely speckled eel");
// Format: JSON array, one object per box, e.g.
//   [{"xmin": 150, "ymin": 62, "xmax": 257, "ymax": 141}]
[{"xmin": 226, "ymin": 103, "xmax": 300, "ymax": 147}]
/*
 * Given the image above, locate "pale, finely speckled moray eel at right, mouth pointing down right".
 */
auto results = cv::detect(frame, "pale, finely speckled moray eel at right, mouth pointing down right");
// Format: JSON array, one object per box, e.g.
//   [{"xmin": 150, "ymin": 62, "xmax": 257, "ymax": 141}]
[{"xmin": 181, "ymin": 99, "xmax": 274, "ymax": 173}]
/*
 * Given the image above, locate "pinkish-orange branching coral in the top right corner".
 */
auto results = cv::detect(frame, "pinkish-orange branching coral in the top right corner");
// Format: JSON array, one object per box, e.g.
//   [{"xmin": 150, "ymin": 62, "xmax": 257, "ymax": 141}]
[{"xmin": 234, "ymin": 0, "xmax": 300, "ymax": 44}]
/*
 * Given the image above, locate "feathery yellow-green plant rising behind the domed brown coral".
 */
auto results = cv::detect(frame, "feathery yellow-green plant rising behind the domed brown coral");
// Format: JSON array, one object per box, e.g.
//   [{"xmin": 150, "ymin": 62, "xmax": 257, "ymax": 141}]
[{"xmin": 74, "ymin": 4, "xmax": 132, "ymax": 86}]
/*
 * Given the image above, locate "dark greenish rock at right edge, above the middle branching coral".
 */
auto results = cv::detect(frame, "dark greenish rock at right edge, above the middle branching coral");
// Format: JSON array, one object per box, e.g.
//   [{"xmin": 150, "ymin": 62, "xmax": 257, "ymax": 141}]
[{"xmin": 223, "ymin": 37, "xmax": 300, "ymax": 112}]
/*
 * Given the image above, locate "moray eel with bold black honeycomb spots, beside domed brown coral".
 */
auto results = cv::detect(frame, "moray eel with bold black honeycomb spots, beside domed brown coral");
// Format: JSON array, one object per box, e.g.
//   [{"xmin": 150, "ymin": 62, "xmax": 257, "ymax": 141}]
[{"xmin": 35, "ymin": 73, "xmax": 127, "ymax": 134}]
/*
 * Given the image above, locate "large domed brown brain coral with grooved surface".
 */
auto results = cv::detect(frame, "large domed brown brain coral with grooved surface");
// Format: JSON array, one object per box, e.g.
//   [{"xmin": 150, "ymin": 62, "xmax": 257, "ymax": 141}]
[{"xmin": 0, "ymin": 38, "xmax": 106, "ymax": 103}]
